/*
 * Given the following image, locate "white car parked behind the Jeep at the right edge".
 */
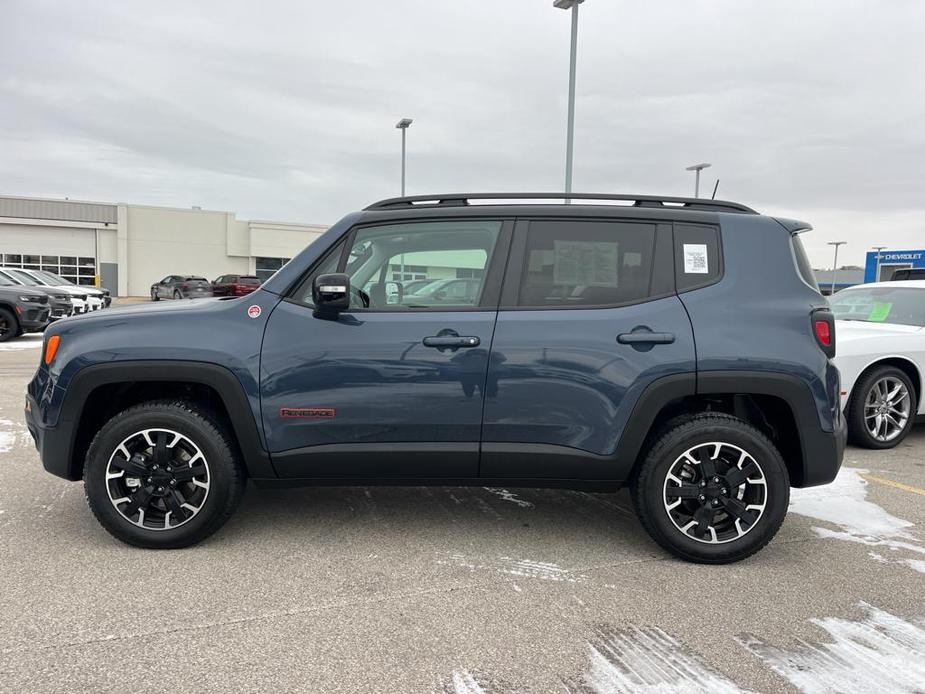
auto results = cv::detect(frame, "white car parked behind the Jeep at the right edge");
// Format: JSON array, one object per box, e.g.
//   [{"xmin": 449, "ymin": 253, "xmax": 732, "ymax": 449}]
[{"xmin": 829, "ymin": 280, "xmax": 925, "ymax": 448}]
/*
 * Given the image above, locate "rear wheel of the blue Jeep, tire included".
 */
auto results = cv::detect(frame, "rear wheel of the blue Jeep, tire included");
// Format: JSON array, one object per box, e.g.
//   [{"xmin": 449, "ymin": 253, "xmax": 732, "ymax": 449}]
[{"xmin": 630, "ymin": 413, "xmax": 790, "ymax": 564}]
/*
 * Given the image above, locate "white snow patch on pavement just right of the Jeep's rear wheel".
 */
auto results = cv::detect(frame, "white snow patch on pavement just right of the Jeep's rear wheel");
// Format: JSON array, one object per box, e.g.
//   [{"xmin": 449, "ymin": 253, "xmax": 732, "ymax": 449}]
[{"xmin": 790, "ymin": 467, "xmax": 925, "ymax": 573}]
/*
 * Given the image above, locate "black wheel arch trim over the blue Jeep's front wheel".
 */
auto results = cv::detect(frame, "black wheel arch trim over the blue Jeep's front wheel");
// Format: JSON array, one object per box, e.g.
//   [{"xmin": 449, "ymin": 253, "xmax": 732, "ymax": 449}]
[{"xmin": 50, "ymin": 360, "xmax": 276, "ymax": 480}]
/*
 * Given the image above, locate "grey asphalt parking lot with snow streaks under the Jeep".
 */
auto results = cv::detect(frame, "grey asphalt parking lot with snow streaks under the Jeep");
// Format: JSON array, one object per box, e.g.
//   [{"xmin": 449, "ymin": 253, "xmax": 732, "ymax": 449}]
[{"xmin": 0, "ymin": 336, "xmax": 925, "ymax": 694}]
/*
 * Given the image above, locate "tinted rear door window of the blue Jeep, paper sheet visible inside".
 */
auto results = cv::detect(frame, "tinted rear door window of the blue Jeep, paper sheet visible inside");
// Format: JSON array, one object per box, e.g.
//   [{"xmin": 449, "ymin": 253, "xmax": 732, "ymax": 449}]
[{"xmin": 517, "ymin": 220, "xmax": 655, "ymax": 308}]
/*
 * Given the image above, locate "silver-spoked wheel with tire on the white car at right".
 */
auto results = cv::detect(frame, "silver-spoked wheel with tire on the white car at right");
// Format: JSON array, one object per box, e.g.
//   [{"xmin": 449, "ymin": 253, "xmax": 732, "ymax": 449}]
[{"xmin": 847, "ymin": 365, "xmax": 918, "ymax": 449}]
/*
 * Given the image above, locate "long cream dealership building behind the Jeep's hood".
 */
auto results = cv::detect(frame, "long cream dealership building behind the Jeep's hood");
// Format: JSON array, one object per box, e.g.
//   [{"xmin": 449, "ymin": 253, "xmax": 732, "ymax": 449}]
[{"xmin": 0, "ymin": 196, "xmax": 327, "ymax": 296}]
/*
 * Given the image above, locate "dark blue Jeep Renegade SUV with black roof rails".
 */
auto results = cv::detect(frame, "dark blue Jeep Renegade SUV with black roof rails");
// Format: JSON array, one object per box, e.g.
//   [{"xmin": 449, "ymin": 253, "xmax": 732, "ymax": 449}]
[{"xmin": 26, "ymin": 194, "xmax": 845, "ymax": 563}]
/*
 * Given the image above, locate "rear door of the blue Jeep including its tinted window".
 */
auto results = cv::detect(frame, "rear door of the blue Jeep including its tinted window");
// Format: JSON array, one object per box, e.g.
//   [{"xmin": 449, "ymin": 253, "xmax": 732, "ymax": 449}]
[{"xmin": 480, "ymin": 219, "xmax": 695, "ymax": 480}]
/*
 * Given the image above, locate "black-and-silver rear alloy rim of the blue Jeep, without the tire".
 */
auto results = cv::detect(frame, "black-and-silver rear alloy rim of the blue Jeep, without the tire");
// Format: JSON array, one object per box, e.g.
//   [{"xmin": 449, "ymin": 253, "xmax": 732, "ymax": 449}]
[{"xmin": 662, "ymin": 441, "xmax": 768, "ymax": 544}]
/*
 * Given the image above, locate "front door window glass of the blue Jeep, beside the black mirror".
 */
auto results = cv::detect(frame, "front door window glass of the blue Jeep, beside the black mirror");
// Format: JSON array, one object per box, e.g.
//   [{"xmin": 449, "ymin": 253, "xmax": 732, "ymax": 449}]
[{"xmin": 298, "ymin": 219, "xmax": 501, "ymax": 311}]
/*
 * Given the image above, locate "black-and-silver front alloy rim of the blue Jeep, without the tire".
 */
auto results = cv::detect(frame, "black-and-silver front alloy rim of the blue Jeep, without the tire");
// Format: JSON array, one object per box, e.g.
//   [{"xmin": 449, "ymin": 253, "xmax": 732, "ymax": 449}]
[{"xmin": 106, "ymin": 429, "xmax": 211, "ymax": 531}]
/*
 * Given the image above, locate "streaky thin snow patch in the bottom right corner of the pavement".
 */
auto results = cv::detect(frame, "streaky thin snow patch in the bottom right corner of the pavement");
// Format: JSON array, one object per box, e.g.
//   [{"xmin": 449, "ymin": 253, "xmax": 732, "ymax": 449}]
[{"xmin": 739, "ymin": 602, "xmax": 925, "ymax": 694}]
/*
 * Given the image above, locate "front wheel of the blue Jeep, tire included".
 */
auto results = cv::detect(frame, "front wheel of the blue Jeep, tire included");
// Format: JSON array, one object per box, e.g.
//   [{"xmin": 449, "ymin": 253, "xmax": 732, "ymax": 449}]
[{"xmin": 84, "ymin": 400, "xmax": 246, "ymax": 549}]
